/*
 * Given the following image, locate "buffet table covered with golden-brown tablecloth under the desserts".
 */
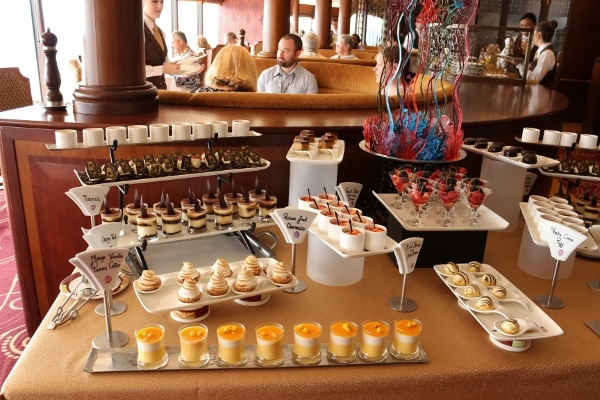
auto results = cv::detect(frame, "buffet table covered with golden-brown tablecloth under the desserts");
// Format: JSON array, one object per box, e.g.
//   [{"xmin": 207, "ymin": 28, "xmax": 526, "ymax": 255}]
[{"xmin": 0, "ymin": 227, "xmax": 600, "ymax": 400}]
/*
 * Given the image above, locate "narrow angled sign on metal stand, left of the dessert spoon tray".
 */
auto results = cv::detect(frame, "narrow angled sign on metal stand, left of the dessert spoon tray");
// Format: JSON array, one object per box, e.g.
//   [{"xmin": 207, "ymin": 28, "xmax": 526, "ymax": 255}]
[{"xmin": 388, "ymin": 237, "xmax": 423, "ymax": 312}]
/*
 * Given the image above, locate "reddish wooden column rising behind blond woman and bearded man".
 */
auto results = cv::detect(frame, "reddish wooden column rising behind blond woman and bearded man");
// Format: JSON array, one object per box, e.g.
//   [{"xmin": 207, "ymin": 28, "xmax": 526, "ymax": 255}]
[{"xmin": 259, "ymin": 0, "xmax": 291, "ymax": 58}]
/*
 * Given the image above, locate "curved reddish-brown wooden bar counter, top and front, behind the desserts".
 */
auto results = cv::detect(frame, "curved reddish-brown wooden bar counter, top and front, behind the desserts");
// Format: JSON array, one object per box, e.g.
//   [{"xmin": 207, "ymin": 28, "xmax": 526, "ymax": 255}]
[{"xmin": 0, "ymin": 82, "xmax": 567, "ymax": 333}]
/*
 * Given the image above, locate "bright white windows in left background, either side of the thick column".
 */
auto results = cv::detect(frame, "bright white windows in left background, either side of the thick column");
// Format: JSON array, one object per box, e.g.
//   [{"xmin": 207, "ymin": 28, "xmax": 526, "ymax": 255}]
[{"xmin": 0, "ymin": 0, "xmax": 221, "ymax": 103}]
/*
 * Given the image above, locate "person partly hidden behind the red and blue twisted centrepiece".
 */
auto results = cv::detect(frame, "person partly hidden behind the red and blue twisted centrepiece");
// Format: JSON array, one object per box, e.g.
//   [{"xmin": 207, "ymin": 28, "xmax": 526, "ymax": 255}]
[{"xmin": 373, "ymin": 46, "xmax": 415, "ymax": 97}]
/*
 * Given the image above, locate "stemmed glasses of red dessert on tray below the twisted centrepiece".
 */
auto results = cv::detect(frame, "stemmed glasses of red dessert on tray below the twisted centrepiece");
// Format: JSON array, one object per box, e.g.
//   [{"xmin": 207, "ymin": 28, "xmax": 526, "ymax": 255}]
[{"xmin": 389, "ymin": 167, "xmax": 492, "ymax": 227}]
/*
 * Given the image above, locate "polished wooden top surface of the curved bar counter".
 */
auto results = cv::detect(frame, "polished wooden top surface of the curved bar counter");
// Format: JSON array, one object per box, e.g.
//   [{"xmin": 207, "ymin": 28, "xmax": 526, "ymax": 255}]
[{"xmin": 0, "ymin": 81, "xmax": 568, "ymax": 137}]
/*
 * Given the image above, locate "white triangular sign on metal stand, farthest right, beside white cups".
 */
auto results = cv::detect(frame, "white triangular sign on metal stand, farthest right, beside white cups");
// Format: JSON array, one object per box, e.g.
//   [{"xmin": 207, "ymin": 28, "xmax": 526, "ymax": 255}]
[{"xmin": 535, "ymin": 222, "xmax": 587, "ymax": 309}]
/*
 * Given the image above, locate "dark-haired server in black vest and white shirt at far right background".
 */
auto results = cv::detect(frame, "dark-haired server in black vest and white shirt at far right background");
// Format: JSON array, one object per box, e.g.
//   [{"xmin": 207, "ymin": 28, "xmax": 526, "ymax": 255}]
[{"xmin": 517, "ymin": 21, "xmax": 558, "ymax": 87}]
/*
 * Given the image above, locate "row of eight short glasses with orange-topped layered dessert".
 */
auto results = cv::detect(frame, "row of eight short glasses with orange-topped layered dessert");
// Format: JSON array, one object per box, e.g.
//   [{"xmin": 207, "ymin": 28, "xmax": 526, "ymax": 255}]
[{"xmin": 135, "ymin": 318, "xmax": 422, "ymax": 369}]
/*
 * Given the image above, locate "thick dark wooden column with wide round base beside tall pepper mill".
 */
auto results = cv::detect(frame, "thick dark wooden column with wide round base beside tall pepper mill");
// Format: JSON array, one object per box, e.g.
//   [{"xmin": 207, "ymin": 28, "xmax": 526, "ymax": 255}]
[{"xmin": 73, "ymin": 0, "xmax": 158, "ymax": 115}]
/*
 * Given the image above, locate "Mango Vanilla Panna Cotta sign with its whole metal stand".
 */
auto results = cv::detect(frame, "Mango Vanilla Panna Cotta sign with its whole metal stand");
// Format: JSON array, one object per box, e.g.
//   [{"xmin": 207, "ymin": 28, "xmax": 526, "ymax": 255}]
[{"xmin": 70, "ymin": 247, "xmax": 129, "ymax": 349}]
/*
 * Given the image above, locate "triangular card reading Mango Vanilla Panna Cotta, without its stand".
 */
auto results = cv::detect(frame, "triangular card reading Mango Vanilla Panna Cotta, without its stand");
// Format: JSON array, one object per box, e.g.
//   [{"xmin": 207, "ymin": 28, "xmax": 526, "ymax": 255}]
[{"xmin": 70, "ymin": 247, "xmax": 129, "ymax": 290}]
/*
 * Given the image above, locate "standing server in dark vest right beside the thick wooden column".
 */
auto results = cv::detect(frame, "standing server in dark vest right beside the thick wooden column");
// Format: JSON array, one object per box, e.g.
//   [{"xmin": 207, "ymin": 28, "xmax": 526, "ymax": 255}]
[{"xmin": 142, "ymin": 0, "xmax": 179, "ymax": 89}]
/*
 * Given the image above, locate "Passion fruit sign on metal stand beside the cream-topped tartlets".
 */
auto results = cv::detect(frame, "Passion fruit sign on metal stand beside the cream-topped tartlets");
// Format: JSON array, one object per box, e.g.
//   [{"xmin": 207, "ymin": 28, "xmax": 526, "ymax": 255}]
[{"xmin": 271, "ymin": 208, "xmax": 317, "ymax": 294}]
